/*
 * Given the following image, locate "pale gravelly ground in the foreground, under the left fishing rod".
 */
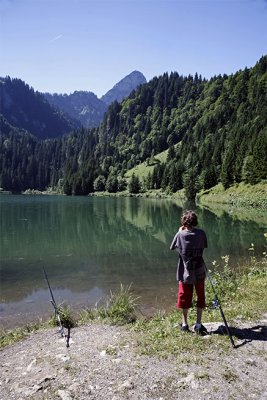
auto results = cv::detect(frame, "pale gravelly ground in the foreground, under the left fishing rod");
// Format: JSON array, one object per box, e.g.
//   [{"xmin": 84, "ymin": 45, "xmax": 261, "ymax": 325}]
[{"xmin": 0, "ymin": 320, "xmax": 267, "ymax": 400}]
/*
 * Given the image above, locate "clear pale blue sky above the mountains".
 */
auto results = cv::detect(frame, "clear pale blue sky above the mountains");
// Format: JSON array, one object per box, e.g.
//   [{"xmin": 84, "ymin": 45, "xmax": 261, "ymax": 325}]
[{"xmin": 0, "ymin": 0, "xmax": 267, "ymax": 97}]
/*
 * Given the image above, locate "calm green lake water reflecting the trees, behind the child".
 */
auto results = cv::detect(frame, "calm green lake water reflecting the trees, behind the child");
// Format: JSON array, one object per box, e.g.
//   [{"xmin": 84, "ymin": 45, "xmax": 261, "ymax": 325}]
[{"xmin": 0, "ymin": 195, "xmax": 266, "ymax": 326}]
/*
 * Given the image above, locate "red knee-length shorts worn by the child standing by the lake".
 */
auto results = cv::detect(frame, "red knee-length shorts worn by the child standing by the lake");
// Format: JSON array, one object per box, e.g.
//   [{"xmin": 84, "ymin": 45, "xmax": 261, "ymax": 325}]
[{"xmin": 177, "ymin": 279, "xmax": 206, "ymax": 308}]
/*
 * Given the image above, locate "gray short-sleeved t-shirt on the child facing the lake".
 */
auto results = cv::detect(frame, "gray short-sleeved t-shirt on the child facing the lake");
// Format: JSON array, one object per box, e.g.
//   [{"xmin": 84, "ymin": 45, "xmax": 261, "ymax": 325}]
[{"xmin": 170, "ymin": 228, "xmax": 208, "ymax": 284}]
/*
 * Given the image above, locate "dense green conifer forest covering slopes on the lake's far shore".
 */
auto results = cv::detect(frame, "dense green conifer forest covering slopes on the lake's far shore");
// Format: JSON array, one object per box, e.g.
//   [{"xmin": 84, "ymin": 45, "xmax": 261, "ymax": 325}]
[{"xmin": 0, "ymin": 56, "xmax": 267, "ymax": 198}]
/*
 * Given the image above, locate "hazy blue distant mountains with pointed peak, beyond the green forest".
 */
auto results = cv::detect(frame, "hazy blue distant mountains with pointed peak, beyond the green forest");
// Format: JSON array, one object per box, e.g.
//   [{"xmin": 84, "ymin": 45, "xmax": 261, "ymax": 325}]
[{"xmin": 0, "ymin": 71, "xmax": 146, "ymax": 139}]
